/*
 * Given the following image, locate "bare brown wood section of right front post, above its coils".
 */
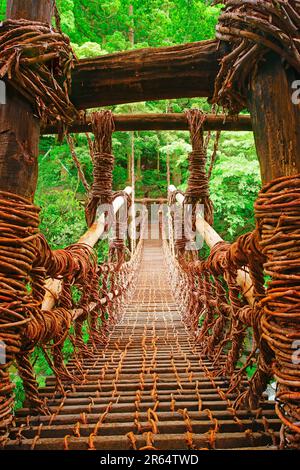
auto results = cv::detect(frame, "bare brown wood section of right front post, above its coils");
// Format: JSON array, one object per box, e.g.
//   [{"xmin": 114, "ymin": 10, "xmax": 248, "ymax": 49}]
[{"xmin": 248, "ymin": 53, "xmax": 300, "ymax": 183}]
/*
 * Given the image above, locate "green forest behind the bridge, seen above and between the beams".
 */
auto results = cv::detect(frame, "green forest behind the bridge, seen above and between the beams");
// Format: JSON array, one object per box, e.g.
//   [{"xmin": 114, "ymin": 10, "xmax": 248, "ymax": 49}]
[{"xmin": 0, "ymin": 0, "xmax": 261, "ymax": 249}]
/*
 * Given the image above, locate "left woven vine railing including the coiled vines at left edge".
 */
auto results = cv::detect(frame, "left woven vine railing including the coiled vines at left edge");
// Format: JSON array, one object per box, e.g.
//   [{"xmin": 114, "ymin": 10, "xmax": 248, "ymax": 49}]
[{"xmin": 0, "ymin": 185, "xmax": 143, "ymax": 440}]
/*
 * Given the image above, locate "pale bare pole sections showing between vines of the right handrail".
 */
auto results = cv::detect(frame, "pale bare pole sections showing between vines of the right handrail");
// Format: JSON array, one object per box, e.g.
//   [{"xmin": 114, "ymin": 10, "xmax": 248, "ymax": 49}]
[{"xmin": 169, "ymin": 185, "xmax": 255, "ymax": 306}]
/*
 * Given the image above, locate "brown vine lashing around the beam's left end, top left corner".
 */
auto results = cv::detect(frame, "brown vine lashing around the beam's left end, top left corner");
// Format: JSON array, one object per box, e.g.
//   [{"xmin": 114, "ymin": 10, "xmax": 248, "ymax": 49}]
[{"xmin": 0, "ymin": 19, "xmax": 78, "ymax": 125}]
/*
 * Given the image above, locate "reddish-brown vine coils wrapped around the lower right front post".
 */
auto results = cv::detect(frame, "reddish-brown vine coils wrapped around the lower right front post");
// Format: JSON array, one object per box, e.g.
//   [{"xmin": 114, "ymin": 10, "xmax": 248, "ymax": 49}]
[{"xmin": 255, "ymin": 175, "xmax": 300, "ymax": 447}]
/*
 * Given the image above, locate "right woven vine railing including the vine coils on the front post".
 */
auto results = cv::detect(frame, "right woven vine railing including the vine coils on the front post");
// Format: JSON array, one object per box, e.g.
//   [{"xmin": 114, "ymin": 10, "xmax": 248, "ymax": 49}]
[{"xmin": 164, "ymin": 175, "xmax": 300, "ymax": 448}]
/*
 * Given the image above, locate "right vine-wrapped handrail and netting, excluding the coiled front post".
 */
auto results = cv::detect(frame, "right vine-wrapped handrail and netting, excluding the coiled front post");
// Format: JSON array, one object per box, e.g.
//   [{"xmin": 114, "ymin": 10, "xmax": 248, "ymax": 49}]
[{"xmin": 164, "ymin": 185, "xmax": 272, "ymax": 409}]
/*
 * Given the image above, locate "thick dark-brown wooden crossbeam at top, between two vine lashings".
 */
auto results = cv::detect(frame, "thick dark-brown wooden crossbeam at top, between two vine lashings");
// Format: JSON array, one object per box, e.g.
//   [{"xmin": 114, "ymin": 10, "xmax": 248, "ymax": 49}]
[{"xmin": 71, "ymin": 40, "xmax": 222, "ymax": 109}]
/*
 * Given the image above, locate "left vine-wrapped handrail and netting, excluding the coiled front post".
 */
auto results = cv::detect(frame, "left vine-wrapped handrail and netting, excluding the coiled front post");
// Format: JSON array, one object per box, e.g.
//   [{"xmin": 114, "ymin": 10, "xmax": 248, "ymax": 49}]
[{"xmin": 10, "ymin": 187, "xmax": 146, "ymax": 413}]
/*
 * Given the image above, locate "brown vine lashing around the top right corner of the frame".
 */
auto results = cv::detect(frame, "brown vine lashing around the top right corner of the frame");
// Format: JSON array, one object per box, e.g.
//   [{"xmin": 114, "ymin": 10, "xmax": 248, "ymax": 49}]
[{"xmin": 213, "ymin": 0, "xmax": 300, "ymax": 113}]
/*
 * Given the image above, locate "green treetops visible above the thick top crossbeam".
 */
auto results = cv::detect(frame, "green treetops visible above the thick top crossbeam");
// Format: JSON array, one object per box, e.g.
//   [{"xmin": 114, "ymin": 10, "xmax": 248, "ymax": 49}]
[{"xmin": 57, "ymin": 0, "xmax": 220, "ymax": 52}]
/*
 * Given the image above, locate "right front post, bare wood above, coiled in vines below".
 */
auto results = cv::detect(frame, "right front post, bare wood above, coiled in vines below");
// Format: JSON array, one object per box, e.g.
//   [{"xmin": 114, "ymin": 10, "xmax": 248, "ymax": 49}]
[{"xmin": 247, "ymin": 5, "xmax": 300, "ymax": 447}]
